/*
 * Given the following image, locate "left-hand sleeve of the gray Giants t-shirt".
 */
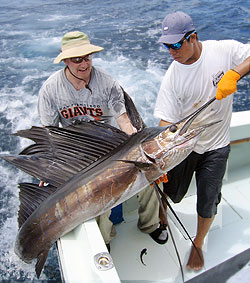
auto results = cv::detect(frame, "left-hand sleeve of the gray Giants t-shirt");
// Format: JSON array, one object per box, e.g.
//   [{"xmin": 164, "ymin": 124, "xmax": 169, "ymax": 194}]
[{"xmin": 37, "ymin": 84, "xmax": 59, "ymax": 126}]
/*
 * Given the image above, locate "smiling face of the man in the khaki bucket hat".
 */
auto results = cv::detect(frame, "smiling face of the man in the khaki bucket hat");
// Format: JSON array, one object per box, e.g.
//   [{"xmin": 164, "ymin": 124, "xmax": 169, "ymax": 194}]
[{"xmin": 64, "ymin": 54, "xmax": 92, "ymax": 81}]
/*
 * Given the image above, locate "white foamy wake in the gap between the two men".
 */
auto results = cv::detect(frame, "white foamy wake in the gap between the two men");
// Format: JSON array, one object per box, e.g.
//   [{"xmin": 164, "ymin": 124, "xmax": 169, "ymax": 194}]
[{"xmin": 93, "ymin": 52, "xmax": 166, "ymax": 126}]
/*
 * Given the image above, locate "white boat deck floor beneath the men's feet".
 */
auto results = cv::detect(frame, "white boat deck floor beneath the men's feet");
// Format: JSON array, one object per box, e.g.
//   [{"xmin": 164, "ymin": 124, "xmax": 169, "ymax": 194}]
[{"xmin": 111, "ymin": 163, "xmax": 250, "ymax": 282}]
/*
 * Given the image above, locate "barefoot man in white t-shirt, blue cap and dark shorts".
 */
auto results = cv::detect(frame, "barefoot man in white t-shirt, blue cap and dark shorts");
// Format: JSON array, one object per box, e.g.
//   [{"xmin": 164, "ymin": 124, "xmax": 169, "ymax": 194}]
[{"xmin": 154, "ymin": 11, "xmax": 250, "ymax": 270}]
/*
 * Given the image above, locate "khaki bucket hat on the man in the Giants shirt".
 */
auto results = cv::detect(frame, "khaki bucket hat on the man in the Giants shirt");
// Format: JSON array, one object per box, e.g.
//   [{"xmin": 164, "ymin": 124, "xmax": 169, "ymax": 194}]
[{"xmin": 54, "ymin": 31, "xmax": 103, "ymax": 64}]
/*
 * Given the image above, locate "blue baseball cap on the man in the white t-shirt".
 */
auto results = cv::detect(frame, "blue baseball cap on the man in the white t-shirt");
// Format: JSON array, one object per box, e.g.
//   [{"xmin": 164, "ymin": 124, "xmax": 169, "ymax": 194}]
[{"xmin": 157, "ymin": 11, "xmax": 195, "ymax": 44}]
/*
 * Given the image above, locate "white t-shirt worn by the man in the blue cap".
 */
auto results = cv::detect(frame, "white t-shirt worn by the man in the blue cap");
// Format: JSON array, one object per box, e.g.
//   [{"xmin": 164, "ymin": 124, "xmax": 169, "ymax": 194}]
[{"xmin": 154, "ymin": 40, "xmax": 250, "ymax": 153}]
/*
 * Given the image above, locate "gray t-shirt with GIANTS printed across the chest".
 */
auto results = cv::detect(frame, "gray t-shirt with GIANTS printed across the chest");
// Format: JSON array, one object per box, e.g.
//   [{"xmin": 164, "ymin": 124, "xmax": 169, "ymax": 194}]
[{"xmin": 38, "ymin": 67, "xmax": 126, "ymax": 127}]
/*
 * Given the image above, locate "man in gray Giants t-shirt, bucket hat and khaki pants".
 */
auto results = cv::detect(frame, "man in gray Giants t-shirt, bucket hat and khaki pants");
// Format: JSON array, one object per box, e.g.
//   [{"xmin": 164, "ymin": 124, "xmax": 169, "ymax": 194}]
[{"xmin": 38, "ymin": 31, "xmax": 168, "ymax": 248}]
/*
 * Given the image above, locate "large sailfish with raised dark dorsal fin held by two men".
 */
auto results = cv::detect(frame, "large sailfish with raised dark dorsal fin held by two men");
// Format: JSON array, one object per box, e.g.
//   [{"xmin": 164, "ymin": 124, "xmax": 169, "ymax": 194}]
[{"xmin": 0, "ymin": 92, "xmax": 217, "ymax": 278}]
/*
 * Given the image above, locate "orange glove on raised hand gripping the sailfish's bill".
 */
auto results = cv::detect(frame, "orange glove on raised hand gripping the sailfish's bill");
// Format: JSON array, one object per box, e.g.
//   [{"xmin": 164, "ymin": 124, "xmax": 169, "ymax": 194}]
[{"xmin": 216, "ymin": 69, "xmax": 240, "ymax": 100}]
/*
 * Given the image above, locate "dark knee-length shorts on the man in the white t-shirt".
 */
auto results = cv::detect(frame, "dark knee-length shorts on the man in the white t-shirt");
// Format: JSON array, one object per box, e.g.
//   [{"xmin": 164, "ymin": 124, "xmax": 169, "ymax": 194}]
[{"xmin": 163, "ymin": 145, "xmax": 230, "ymax": 218}]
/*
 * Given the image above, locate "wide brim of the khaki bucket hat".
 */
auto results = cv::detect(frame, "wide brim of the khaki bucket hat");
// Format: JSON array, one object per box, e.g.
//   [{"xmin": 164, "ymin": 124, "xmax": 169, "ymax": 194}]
[{"xmin": 54, "ymin": 44, "xmax": 104, "ymax": 64}]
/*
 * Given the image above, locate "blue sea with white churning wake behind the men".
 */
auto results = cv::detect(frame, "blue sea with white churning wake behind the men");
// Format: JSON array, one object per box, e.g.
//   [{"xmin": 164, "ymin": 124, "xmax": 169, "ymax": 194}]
[{"xmin": 0, "ymin": 0, "xmax": 250, "ymax": 282}]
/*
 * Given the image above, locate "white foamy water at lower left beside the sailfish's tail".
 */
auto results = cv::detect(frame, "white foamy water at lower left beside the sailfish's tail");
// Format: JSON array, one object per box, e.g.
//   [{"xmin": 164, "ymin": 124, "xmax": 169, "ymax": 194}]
[{"xmin": 0, "ymin": 165, "xmax": 34, "ymax": 280}]
